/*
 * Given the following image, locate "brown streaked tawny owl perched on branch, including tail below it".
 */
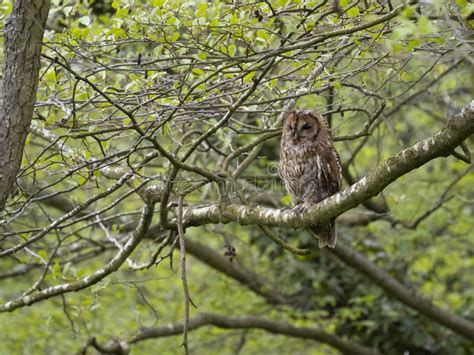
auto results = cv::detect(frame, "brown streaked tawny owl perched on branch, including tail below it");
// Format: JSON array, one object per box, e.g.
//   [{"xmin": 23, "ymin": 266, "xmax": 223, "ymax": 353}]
[{"xmin": 280, "ymin": 111, "xmax": 341, "ymax": 248}]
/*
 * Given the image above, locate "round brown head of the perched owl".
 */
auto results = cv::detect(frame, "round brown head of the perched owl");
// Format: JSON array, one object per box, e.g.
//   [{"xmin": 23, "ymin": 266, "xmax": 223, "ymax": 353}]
[{"xmin": 283, "ymin": 110, "xmax": 324, "ymax": 144}]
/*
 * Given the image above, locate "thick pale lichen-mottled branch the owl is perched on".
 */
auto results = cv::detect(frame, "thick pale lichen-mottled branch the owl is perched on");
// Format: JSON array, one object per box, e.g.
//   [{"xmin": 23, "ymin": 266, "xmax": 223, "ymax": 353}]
[{"xmin": 184, "ymin": 101, "xmax": 474, "ymax": 228}]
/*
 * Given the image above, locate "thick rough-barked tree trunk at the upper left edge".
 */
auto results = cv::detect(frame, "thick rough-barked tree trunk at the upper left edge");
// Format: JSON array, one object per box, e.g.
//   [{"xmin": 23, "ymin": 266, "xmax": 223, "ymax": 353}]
[{"xmin": 0, "ymin": 0, "xmax": 50, "ymax": 211}]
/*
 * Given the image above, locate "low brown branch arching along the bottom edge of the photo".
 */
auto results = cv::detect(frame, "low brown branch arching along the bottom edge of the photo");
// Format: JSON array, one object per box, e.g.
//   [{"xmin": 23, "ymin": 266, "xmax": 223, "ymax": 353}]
[{"xmin": 130, "ymin": 313, "xmax": 379, "ymax": 354}]
